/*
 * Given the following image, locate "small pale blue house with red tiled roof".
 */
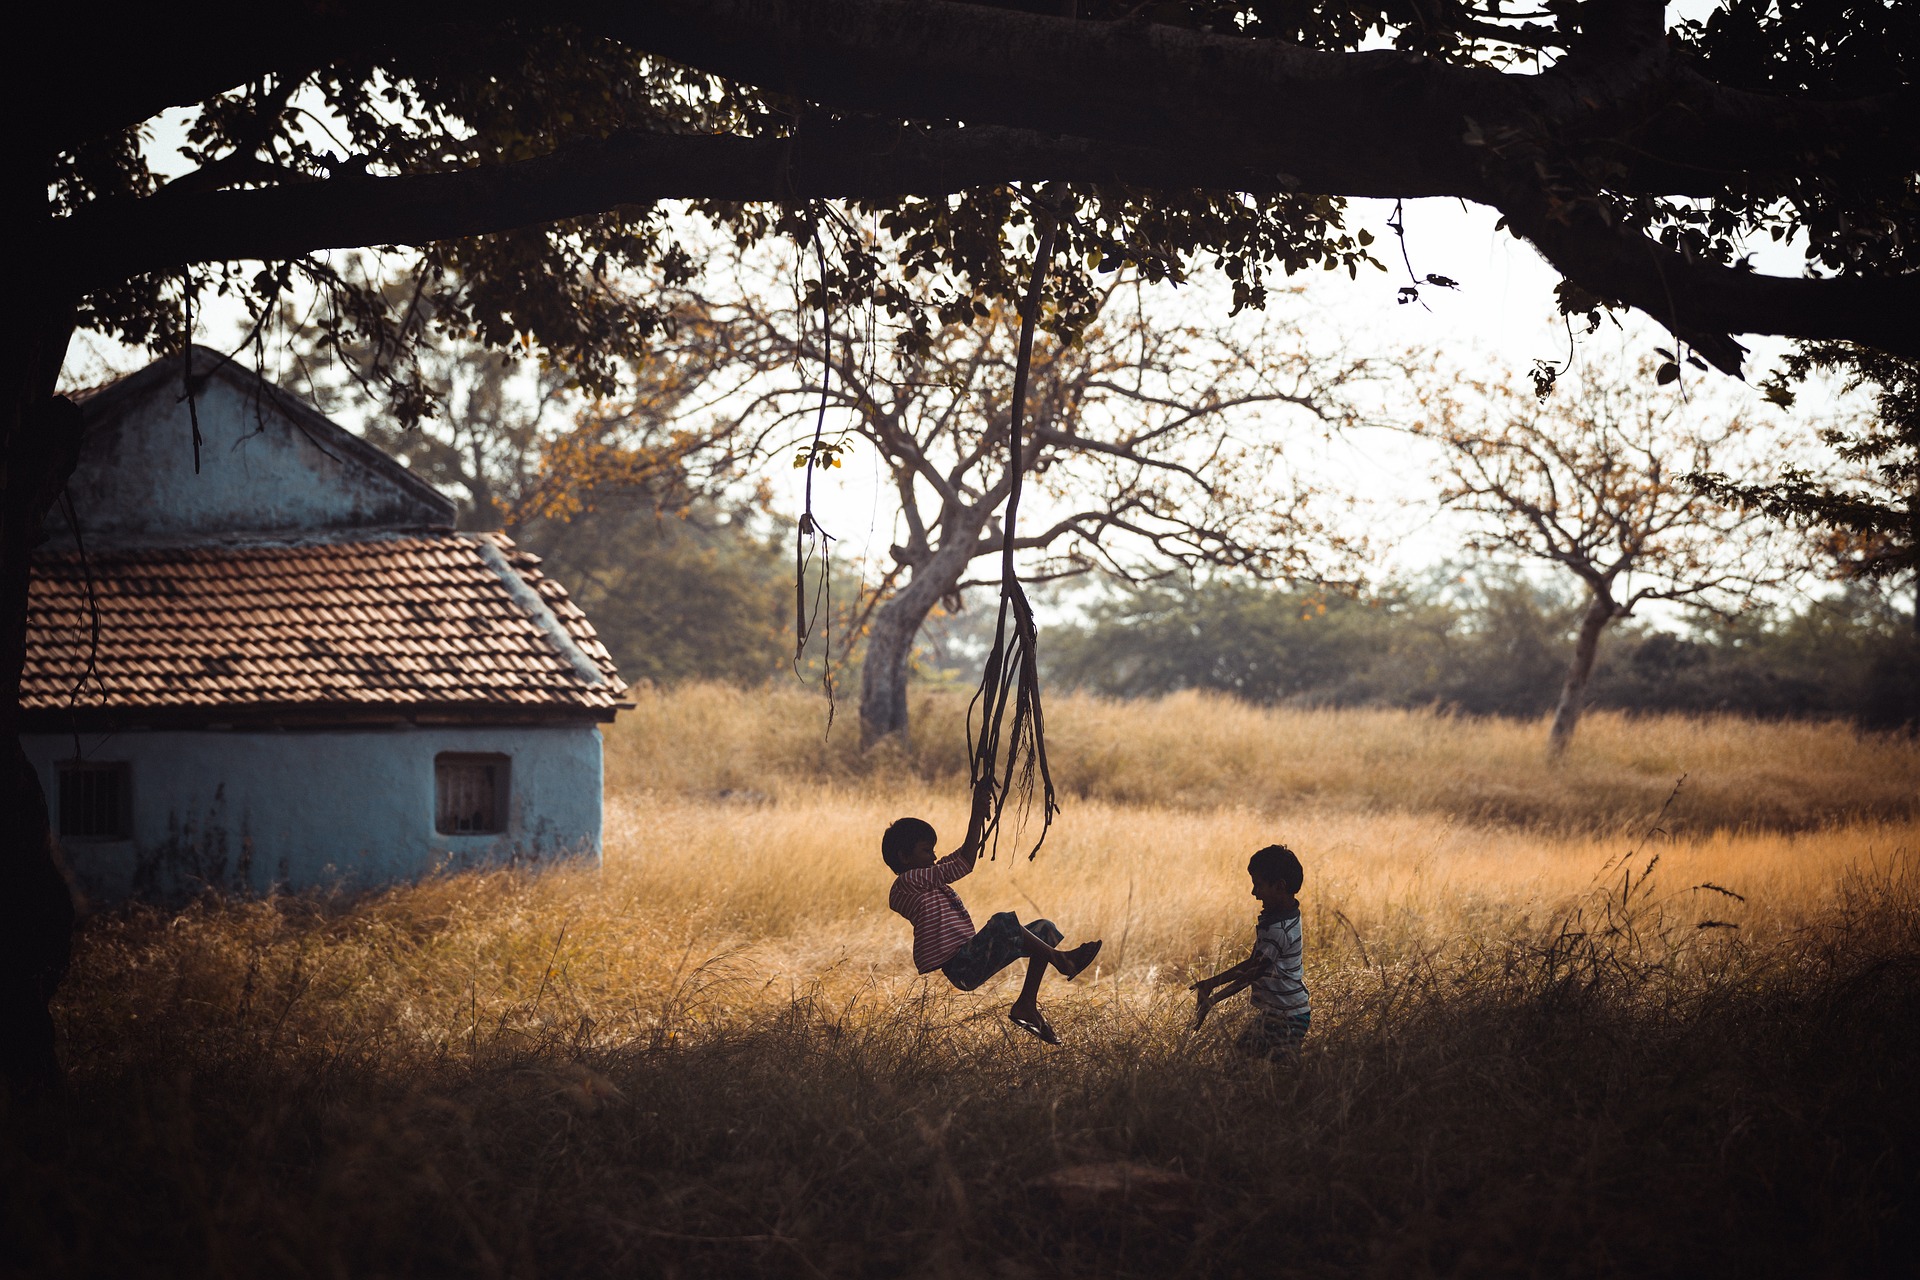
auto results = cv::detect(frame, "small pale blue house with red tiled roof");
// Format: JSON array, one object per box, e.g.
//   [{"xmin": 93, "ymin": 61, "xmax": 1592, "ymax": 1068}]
[{"xmin": 21, "ymin": 347, "xmax": 622, "ymax": 902}]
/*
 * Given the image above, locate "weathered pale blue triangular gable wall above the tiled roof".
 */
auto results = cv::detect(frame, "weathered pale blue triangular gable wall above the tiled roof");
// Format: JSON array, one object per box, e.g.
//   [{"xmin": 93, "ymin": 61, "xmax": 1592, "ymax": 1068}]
[{"xmin": 48, "ymin": 357, "xmax": 453, "ymax": 545}]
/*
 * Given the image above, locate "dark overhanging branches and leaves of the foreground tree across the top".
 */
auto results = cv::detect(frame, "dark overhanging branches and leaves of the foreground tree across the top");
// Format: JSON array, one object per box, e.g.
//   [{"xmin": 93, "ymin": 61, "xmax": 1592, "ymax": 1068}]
[{"xmin": 41, "ymin": 0, "xmax": 1920, "ymax": 395}]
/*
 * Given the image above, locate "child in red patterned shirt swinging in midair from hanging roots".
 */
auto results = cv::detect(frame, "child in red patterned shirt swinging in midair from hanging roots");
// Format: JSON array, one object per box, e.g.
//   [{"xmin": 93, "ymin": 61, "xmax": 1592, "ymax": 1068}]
[{"xmin": 879, "ymin": 783, "xmax": 1100, "ymax": 1044}]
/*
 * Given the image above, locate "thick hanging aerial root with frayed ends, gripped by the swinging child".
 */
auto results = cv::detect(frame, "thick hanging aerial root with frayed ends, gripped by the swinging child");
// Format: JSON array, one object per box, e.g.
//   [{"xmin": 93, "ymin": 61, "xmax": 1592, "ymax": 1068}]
[{"xmin": 966, "ymin": 217, "xmax": 1060, "ymax": 860}]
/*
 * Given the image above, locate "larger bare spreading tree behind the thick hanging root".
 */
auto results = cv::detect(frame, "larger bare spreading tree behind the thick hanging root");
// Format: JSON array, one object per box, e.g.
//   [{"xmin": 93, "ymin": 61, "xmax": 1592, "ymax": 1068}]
[{"xmin": 652, "ymin": 259, "xmax": 1369, "ymax": 743}]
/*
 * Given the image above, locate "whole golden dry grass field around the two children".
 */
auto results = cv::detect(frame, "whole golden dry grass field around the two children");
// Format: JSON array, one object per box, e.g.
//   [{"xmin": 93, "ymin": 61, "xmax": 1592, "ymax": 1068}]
[{"xmin": 4, "ymin": 687, "xmax": 1920, "ymax": 1278}]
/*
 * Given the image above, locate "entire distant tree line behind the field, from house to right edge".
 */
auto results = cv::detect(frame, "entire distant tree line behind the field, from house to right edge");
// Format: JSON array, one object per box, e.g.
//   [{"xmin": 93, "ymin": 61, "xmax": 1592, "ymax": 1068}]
[{"xmin": 516, "ymin": 485, "xmax": 1920, "ymax": 729}]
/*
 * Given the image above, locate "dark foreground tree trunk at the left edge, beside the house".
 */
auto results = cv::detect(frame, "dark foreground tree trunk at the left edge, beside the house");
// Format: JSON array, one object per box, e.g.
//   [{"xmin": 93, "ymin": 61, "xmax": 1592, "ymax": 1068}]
[{"xmin": 0, "ymin": 282, "xmax": 81, "ymax": 1096}]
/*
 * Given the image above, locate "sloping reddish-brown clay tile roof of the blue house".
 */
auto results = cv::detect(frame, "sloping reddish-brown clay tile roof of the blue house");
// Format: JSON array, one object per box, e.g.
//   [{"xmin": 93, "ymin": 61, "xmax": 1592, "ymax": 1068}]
[{"xmin": 21, "ymin": 533, "xmax": 622, "ymax": 718}]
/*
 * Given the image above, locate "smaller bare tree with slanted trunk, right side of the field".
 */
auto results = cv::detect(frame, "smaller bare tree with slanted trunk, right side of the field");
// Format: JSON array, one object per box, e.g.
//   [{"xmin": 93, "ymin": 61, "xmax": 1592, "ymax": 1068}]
[{"xmin": 1417, "ymin": 367, "xmax": 1791, "ymax": 758}]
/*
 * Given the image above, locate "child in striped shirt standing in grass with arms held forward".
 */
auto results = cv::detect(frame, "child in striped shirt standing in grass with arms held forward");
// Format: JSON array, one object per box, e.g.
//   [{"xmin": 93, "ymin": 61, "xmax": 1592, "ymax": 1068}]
[{"xmin": 1192, "ymin": 844, "xmax": 1311, "ymax": 1057}]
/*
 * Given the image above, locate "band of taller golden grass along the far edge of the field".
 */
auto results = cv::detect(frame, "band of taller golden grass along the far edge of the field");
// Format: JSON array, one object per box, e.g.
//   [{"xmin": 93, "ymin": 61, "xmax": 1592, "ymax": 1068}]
[{"xmin": 607, "ymin": 685, "xmax": 1920, "ymax": 833}]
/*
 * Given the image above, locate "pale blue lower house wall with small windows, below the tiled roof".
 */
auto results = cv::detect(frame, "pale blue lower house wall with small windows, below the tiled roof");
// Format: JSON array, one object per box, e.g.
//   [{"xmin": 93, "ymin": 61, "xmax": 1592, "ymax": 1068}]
[{"xmin": 21, "ymin": 725, "xmax": 601, "ymax": 906}]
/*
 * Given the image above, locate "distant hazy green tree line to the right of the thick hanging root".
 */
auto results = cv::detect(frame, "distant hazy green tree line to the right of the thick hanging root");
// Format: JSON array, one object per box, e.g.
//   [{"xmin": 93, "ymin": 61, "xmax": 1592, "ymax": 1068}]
[{"xmin": 1043, "ymin": 576, "xmax": 1920, "ymax": 727}]
